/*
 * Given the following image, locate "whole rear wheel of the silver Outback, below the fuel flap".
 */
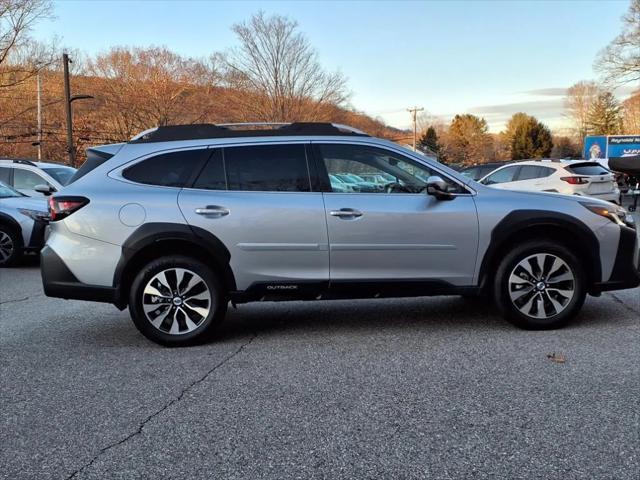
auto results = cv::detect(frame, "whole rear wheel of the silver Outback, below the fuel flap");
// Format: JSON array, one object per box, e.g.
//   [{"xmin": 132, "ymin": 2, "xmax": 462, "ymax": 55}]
[{"xmin": 129, "ymin": 255, "xmax": 227, "ymax": 346}]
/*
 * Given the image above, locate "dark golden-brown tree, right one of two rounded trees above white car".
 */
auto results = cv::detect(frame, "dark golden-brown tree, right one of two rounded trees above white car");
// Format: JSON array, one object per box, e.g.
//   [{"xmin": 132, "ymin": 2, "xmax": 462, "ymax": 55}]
[{"xmin": 506, "ymin": 112, "xmax": 553, "ymax": 160}]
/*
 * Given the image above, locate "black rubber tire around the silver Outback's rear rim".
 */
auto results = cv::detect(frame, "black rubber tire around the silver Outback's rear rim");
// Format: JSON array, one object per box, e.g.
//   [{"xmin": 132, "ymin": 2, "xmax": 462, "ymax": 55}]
[{"xmin": 129, "ymin": 255, "xmax": 228, "ymax": 347}]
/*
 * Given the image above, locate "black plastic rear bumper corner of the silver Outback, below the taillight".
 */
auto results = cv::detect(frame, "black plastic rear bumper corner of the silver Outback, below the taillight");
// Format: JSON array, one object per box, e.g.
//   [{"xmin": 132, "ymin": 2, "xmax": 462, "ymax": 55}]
[{"xmin": 40, "ymin": 245, "xmax": 120, "ymax": 306}]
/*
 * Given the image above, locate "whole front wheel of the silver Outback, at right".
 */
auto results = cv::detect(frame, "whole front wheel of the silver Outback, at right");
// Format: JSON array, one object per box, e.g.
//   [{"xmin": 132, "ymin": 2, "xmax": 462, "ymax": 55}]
[{"xmin": 494, "ymin": 240, "xmax": 587, "ymax": 330}]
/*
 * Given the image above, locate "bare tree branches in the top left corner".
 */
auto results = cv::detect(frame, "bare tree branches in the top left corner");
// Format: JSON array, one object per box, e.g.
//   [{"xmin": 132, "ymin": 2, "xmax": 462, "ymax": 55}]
[{"xmin": 0, "ymin": 0, "xmax": 53, "ymax": 88}]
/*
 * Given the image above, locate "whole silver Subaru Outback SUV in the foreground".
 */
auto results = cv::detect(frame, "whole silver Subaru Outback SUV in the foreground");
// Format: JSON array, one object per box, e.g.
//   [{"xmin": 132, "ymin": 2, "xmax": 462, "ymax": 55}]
[{"xmin": 42, "ymin": 123, "xmax": 640, "ymax": 345}]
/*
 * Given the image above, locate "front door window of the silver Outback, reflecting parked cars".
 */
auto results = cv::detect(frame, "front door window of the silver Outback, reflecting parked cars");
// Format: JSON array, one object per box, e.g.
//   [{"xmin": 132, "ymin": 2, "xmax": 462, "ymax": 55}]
[{"xmin": 317, "ymin": 144, "xmax": 463, "ymax": 193}]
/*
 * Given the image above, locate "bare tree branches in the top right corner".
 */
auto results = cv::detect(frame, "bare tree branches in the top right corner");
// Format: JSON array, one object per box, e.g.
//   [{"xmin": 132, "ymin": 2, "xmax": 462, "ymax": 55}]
[{"xmin": 595, "ymin": 0, "xmax": 640, "ymax": 85}]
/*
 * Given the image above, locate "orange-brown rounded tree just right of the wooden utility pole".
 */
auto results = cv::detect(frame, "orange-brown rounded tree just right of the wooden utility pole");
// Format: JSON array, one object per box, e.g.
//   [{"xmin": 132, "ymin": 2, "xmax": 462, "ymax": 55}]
[{"xmin": 445, "ymin": 113, "xmax": 492, "ymax": 164}]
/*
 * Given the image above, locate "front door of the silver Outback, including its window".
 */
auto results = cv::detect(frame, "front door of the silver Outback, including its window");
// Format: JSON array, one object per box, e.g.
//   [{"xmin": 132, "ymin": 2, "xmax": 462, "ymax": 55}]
[{"xmin": 314, "ymin": 143, "xmax": 478, "ymax": 286}]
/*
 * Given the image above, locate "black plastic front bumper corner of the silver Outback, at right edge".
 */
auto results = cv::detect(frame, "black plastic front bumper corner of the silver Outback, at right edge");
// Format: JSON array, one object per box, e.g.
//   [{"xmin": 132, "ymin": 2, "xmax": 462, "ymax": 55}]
[{"xmin": 592, "ymin": 227, "xmax": 640, "ymax": 293}]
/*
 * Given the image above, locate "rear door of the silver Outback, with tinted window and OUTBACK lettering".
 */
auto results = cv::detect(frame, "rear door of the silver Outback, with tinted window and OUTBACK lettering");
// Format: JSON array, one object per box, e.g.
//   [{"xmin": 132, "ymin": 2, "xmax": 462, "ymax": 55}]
[{"xmin": 178, "ymin": 142, "xmax": 329, "ymax": 294}]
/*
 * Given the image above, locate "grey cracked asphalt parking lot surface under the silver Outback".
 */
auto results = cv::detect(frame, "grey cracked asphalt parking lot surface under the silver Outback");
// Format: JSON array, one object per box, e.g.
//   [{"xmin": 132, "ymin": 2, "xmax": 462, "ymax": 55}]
[{"xmin": 0, "ymin": 265, "xmax": 640, "ymax": 479}]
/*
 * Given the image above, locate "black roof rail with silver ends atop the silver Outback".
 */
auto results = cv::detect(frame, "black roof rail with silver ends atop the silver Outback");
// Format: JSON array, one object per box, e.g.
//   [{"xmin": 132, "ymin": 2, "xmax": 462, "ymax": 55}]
[{"xmin": 129, "ymin": 122, "xmax": 368, "ymax": 143}]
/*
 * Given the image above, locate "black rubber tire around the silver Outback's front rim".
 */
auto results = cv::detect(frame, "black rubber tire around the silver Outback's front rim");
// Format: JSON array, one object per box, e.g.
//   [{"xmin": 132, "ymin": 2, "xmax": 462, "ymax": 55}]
[{"xmin": 493, "ymin": 239, "xmax": 587, "ymax": 330}]
